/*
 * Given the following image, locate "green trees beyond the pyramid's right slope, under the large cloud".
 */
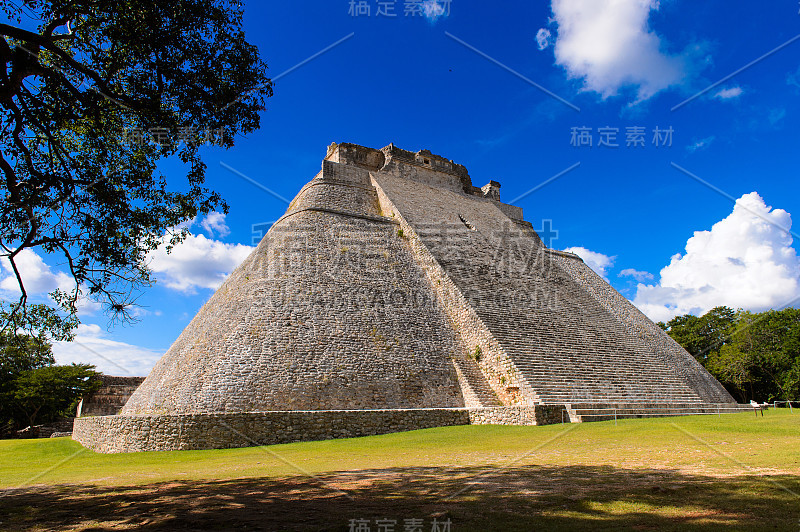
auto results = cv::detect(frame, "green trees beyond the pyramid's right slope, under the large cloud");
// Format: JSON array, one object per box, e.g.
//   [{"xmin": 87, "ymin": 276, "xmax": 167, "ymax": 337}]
[{"xmin": 658, "ymin": 307, "xmax": 800, "ymax": 403}]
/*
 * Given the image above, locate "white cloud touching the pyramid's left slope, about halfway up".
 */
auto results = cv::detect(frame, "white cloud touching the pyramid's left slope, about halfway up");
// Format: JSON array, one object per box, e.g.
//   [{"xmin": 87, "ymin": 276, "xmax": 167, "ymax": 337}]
[{"xmin": 150, "ymin": 235, "xmax": 254, "ymax": 293}]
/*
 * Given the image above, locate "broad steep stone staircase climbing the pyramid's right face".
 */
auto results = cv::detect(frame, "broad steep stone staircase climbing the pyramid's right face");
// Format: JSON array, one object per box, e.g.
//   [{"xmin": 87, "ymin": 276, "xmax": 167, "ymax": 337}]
[{"xmin": 374, "ymin": 168, "xmax": 708, "ymax": 404}]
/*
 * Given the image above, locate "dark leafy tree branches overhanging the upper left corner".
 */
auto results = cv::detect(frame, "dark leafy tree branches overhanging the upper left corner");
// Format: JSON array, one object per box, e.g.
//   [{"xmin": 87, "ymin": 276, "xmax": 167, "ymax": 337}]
[{"xmin": 0, "ymin": 0, "xmax": 272, "ymax": 330}]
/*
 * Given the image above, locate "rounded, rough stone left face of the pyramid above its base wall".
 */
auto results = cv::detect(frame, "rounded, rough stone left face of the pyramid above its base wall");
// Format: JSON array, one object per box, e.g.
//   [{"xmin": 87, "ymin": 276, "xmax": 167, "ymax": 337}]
[{"xmin": 122, "ymin": 156, "xmax": 464, "ymax": 414}]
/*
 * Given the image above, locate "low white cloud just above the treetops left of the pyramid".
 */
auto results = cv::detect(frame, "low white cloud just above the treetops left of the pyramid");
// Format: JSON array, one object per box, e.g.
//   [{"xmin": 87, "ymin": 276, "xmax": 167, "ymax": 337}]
[{"xmin": 53, "ymin": 324, "xmax": 164, "ymax": 377}]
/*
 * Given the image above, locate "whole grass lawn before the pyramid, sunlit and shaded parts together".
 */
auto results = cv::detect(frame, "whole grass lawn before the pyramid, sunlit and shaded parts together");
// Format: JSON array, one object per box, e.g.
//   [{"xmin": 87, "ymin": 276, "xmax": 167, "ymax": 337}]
[{"xmin": 0, "ymin": 410, "xmax": 800, "ymax": 532}]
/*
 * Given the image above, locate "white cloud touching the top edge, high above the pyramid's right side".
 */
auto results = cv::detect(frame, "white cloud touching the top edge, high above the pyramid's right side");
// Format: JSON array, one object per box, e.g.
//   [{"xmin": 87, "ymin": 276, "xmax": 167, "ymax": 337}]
[{"xmin": 552, "ymin": 0, "xmax": 688, "ymax": 101}]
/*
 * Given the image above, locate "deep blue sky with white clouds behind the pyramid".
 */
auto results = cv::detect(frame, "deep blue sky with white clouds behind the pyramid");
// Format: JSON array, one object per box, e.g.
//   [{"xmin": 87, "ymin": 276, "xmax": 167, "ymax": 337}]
[{"xmin": 6, "ymin": 0, "xmax": 800, "ymax": 374}]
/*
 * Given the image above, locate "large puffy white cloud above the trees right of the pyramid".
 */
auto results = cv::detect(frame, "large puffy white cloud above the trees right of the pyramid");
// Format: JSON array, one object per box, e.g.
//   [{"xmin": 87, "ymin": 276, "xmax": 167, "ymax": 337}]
[{"xmin": 634, "ymin": 192, "xmax": 800, "ymax": 321}]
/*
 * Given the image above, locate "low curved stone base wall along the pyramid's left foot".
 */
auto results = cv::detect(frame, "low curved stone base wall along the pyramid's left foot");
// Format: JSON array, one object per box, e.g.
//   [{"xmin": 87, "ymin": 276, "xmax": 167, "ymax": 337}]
[{"xmin": 72, "ymin": 406, "xmax": 563, "ymax": 453}]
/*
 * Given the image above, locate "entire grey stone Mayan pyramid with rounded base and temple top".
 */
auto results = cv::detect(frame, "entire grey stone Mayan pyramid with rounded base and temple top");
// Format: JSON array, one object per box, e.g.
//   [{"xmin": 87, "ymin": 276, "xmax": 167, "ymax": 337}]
[{"xmin": 75, "ymin": 144, "xmax": 735, "ymax": 451}]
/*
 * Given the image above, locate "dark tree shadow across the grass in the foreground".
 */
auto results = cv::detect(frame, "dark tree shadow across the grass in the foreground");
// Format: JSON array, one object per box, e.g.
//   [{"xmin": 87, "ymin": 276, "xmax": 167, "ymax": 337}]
[{"xmin": 0, "ymin": 466, "xmax": 800, "ymax": 532}]
